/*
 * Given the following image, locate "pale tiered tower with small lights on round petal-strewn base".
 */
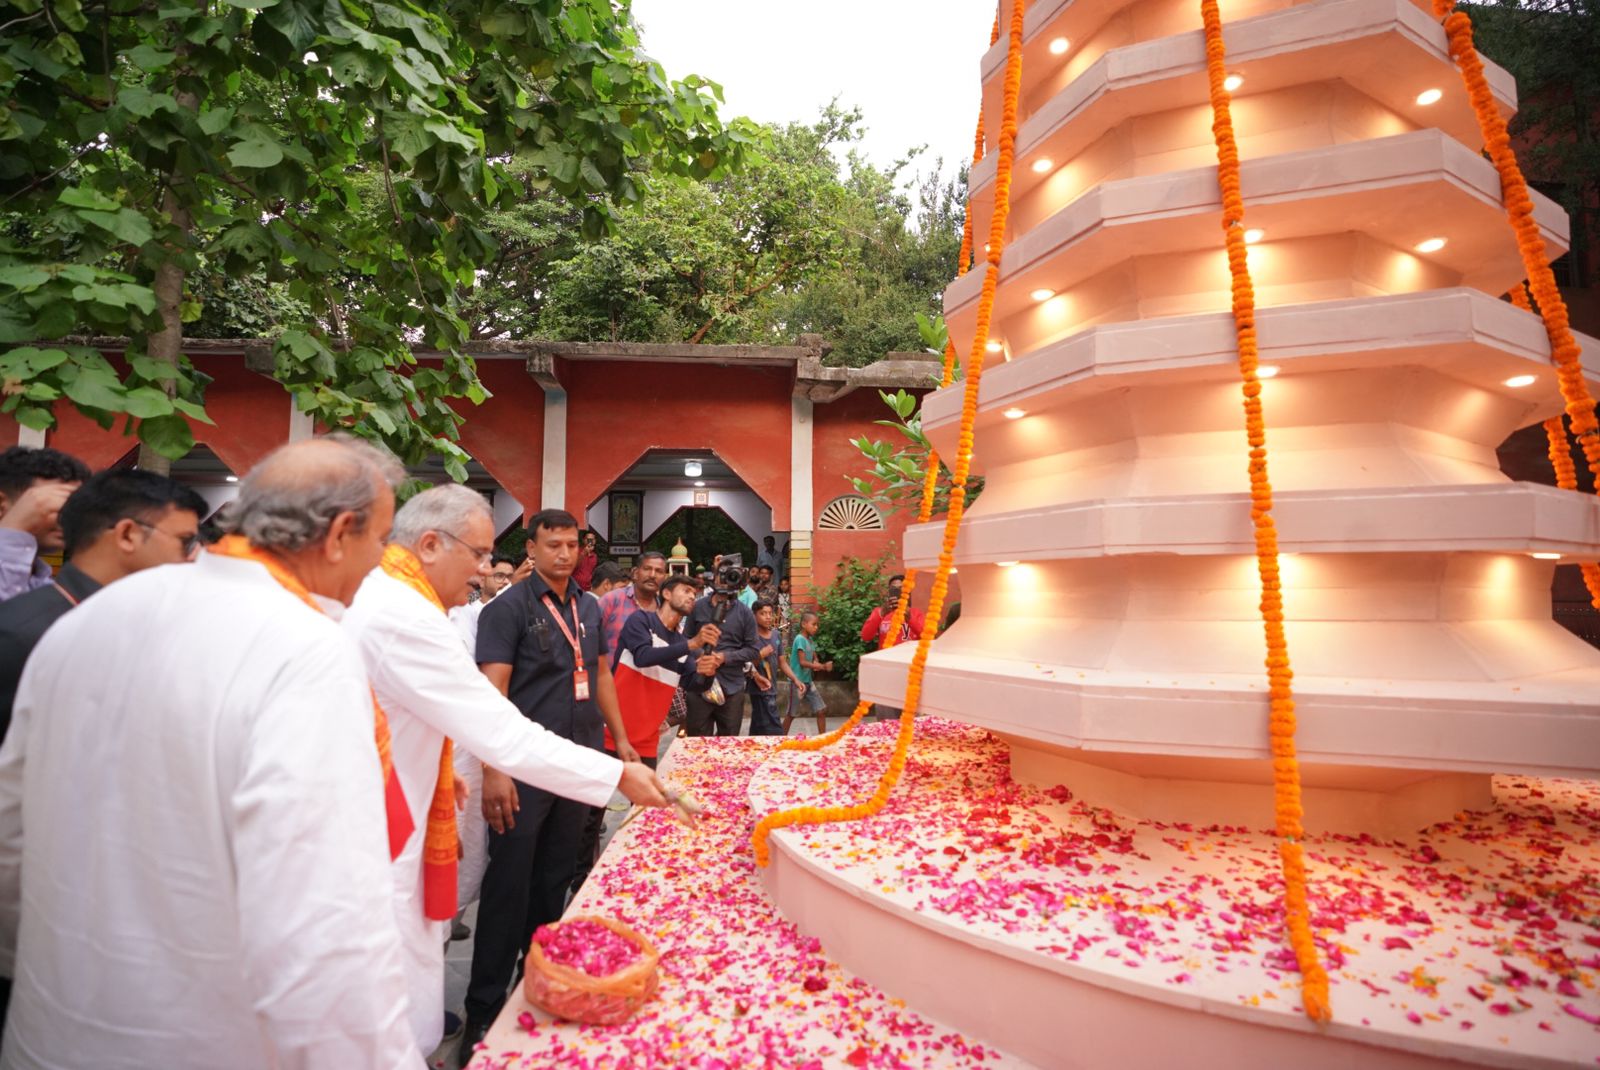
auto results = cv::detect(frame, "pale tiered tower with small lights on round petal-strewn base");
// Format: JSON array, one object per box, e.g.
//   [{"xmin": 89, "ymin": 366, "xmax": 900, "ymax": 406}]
[{"xmin": 750, "ymin": 0, "xmax": 1600, "ymax": 1067}]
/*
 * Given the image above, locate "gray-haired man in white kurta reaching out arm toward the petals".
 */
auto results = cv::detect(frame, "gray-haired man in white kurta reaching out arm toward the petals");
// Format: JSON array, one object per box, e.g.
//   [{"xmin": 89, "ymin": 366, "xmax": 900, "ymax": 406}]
[{"xmin": 344, "ymin": 486, "xmax": 667, "ymax": 1052}]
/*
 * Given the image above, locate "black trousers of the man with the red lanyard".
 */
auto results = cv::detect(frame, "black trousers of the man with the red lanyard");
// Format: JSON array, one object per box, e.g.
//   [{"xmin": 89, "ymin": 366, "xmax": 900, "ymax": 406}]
[{"xmin": 466, "ymin": 784, "xmax": 594, "ymax": 1024}]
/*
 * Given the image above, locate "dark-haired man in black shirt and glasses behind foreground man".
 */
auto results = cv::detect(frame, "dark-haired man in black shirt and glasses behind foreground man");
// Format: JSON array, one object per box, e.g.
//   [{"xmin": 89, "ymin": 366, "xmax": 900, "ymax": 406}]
[{"xmin": 0, "ymin": 469, "xmax": 208, "ymax": 739}]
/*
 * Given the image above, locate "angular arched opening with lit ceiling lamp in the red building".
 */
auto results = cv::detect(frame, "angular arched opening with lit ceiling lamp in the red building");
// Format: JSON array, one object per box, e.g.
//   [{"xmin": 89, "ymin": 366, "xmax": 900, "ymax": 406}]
[{"xmin": 584, "ymin": 449, "xmax": 782, "ymax": 568}]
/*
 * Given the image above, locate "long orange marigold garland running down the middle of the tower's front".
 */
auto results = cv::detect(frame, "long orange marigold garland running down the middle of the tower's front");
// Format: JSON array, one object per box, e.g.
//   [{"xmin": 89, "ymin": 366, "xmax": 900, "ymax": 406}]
[{"xmin": 1200, "ymin": 0, "xmax": 1331, "ymax": 1022}]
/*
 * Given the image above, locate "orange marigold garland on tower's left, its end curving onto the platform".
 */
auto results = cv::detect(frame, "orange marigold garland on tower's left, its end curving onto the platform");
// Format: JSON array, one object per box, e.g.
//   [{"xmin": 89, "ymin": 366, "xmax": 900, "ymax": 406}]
[{"xmin": 750, "ymin": 0, "xmax": 1026, "ymax": 865}]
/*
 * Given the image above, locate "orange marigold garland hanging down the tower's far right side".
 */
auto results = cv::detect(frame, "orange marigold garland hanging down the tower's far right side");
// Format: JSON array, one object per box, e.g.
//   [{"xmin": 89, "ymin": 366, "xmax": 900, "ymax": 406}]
[{"xmin": 1434, "ymin": 0, "xmax": 1600, "ymax": 609}]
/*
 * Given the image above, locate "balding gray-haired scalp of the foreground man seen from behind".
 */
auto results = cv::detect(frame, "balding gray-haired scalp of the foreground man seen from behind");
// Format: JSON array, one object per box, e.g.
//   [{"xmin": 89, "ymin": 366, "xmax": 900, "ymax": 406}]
[{"xmin": 227, "ymin": 433, "xmax": 405, "ymax": 553}]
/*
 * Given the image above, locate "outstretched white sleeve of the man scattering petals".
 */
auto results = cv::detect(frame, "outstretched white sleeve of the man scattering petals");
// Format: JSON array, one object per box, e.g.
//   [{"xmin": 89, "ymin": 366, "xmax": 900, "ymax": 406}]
[{"xmin": 374, "ymin": 614, "xmax": 622, "ymax": 806}]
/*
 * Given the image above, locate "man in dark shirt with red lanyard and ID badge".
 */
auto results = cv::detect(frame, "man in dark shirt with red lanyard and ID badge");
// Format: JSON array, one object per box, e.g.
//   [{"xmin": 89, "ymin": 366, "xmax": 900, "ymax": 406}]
[{"xmin": 461, "ymin": 509, "xmax": 638, "ymax": 1051}]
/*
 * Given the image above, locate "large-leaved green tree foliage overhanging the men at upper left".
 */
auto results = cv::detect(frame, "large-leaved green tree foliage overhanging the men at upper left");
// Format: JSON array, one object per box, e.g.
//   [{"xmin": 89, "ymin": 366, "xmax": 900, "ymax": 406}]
[{"xmin": 0, "ymin": 0, "xmax": 757, "ymax": 478}]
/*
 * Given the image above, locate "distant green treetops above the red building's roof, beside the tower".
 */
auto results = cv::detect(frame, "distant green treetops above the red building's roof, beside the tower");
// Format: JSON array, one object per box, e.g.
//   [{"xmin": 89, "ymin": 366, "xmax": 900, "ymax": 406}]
[{"xmin": 521, "ymin": 106, "xmax": 962, "ymax": 365}]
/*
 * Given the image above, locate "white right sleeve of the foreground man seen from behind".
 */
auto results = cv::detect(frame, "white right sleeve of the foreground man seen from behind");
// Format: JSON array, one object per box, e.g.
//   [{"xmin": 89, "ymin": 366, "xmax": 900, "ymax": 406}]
[{"xmin": 229, "ymin": 643, "xmax": 424, "ymax": 1070}]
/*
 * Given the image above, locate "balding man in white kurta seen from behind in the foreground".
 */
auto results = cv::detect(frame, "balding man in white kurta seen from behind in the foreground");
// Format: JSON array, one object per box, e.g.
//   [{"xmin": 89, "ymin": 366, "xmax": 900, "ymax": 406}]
[{"xmin": 0, "ymin": 440, "xmax": 424, "ymax": 1070}]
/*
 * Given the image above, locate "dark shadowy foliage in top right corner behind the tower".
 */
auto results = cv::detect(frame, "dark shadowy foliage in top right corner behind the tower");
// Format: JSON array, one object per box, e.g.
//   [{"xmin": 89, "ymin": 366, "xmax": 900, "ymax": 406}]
[{"xmin": 1464, "ymin": 0, "xmax": 1600, "ymax": 275}]
